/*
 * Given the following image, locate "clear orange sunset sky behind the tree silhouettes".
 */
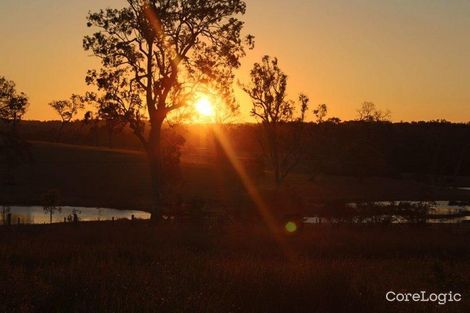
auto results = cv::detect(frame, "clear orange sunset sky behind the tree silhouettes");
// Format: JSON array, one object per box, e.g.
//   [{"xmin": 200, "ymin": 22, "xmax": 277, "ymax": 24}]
[{"xmin": 0, "ymin": 0, "xmax": 470, "ymax": 121}]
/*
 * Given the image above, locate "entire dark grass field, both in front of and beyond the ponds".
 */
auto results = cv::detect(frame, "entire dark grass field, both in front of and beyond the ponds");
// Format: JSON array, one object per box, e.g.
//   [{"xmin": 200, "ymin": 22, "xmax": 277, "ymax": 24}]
[{"xmin": 0, "ymin": 142, "xmax": 470, "ymax": 313}]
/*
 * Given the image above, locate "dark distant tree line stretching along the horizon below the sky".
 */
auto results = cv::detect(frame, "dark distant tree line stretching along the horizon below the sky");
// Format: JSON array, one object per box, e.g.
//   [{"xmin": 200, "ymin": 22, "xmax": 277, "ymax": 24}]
[{"xmin": 13, "ymin": 121, "xmax": 470, "ymax": 182}]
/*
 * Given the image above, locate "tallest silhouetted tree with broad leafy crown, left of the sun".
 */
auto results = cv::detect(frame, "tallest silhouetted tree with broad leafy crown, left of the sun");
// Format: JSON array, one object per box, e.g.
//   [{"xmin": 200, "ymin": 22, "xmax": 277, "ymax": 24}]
[{"xmin": 83, "ymin": 0, "xmax": 253, "ymax": 218}]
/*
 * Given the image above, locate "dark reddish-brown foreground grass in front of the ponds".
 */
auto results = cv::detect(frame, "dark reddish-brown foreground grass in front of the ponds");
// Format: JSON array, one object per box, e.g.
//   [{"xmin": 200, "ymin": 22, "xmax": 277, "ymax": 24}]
[{"xmin": 0, "ymin": 222, "xmax": 470, "ymax": 313}]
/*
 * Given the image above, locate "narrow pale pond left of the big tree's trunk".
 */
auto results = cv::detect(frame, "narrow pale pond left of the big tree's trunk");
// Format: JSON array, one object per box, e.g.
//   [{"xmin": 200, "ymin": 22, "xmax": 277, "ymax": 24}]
[{"xmin": 0, "ymin": 206, "xmax": 150, "ymax": 224}]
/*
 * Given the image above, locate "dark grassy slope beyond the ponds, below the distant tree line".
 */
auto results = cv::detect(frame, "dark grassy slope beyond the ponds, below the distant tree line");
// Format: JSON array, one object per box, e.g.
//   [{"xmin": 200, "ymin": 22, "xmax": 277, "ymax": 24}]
[{"xmin": 0, "ymin": 142, "xmax": 470, "ymax": 210}]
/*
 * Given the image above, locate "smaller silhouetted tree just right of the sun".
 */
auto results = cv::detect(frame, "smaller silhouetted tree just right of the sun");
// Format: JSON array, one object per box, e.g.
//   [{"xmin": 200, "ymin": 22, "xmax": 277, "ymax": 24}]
[{"xmin": 243, "ymin": 56, "xmax": 309, "ymax": 186}]
